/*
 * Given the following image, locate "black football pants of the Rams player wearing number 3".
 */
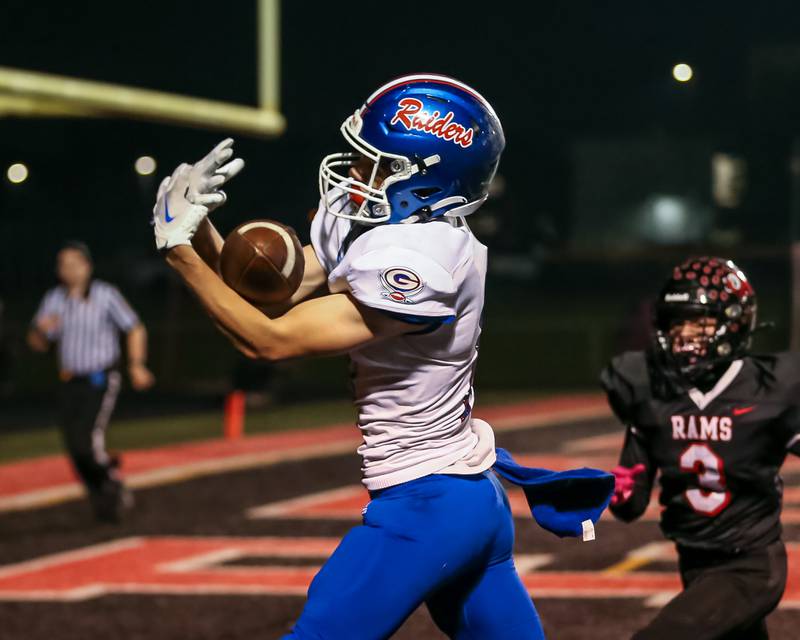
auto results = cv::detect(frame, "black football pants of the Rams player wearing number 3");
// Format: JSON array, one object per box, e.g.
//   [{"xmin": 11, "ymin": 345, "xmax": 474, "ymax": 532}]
[{"xmin": 633, "ymin": 540, "xmax": 787, "ymax": 640}]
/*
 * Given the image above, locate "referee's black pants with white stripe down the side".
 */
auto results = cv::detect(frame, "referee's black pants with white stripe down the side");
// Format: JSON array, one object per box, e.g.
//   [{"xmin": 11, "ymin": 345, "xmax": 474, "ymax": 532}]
[{"xmin": 59, "ymin": 370, "xmax": 121, "ymax": 497}]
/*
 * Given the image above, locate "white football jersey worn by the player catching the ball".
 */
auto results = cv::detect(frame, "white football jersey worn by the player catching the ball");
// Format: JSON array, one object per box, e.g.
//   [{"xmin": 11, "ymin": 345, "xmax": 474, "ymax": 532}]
[{"xmin": 311, "ymin": 191, "xmax": 494, "ymax": 490}]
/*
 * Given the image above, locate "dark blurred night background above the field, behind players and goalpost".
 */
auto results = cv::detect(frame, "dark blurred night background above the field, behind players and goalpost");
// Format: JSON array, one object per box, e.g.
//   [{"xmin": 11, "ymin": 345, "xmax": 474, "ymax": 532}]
[{"xmin": 0, "ymin": 0, "xmax": 800, "ymax": 430}]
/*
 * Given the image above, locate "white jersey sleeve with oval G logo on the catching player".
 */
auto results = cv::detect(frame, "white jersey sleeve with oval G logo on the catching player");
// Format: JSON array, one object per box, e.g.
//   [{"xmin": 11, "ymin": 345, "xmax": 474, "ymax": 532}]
[{"xmin": 330, "ymin": 247, "xmax": 456, "ymax": 321}]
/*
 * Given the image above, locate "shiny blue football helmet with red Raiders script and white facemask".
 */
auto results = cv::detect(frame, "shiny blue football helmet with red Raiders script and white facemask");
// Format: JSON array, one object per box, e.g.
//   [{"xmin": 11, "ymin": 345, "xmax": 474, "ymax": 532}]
[{"xmin": 319, "ymin": 74, "xmax": 505, "ymax": 224}]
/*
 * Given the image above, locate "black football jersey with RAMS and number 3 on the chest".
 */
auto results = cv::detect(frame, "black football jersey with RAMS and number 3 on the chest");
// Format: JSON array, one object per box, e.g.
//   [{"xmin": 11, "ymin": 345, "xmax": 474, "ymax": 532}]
[{"xmin": 601, "ymin": 352, "xmax": 800, "ymax": 551}]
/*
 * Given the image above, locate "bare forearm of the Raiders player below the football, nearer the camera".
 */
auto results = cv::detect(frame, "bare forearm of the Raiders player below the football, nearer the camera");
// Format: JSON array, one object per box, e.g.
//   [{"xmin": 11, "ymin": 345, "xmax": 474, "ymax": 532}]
[{"xmin": 167, "ymin": 245, "xmax": 288, "ymax": 360}]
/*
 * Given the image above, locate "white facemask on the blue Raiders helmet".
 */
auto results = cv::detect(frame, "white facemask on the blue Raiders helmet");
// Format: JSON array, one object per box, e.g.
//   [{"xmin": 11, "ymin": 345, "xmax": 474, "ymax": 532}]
[{"xmin": 319, "ymin": 111, "xmax": 439, "ymax": 224}]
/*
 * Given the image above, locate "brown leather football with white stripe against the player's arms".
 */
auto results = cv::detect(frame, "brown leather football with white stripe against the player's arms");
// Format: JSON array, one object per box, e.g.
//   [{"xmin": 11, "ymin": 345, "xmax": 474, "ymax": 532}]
[{"xmin": 220, "ymin": 220, "xmax": 305, "ymax": 304}]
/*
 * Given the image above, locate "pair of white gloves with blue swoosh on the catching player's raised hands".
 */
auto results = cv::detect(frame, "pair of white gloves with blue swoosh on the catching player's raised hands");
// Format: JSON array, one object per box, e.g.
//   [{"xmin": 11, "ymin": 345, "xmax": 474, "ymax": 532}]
[{"xmin": 153, "ymin": 138, "xmax": 244, "ymax": 249}]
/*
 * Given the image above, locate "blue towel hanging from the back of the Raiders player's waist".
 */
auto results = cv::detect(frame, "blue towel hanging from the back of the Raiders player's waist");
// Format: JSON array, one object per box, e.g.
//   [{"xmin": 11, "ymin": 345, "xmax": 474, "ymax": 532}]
[{"xmin": 494, "ymin": 448, "xmax": 614, "ymax": 538}]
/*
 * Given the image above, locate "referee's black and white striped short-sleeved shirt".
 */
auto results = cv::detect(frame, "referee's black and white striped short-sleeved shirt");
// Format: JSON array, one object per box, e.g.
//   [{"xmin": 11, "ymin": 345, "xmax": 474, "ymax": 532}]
[{"xmin": 34, "ymin": 280, "xmax": 139, "ymax": 375}]
